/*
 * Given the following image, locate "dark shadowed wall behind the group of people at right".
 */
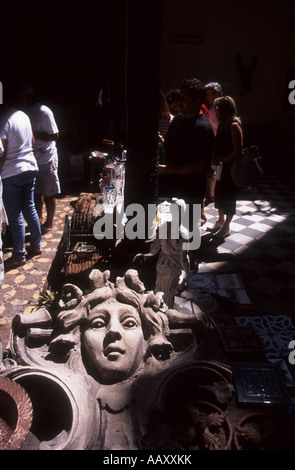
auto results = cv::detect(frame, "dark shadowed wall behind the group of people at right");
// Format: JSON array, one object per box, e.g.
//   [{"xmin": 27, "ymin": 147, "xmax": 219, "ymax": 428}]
[{"xmin": 161, "ymin": 0, "xmax": 295, "ymax": 165}]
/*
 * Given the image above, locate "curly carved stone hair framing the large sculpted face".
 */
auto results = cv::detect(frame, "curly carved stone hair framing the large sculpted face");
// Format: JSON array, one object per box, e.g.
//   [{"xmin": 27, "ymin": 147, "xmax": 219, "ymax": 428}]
[{"xmin": 49, "ymin": 269, "xmax": 173, "ymax": 360}]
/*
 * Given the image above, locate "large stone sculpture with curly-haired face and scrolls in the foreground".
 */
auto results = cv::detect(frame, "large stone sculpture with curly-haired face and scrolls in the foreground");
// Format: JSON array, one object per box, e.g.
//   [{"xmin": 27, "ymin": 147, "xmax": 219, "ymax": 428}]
[{"xmin": 0, "ymin": 269, "xmax": 233, "ymax": 450}]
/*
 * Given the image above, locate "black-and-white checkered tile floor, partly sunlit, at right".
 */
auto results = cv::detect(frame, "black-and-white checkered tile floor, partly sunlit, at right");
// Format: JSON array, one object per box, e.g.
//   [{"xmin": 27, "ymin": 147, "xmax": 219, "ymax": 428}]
[{"xmin": 199, "ymin": 175, "xmax": 295, "ymax": 315}]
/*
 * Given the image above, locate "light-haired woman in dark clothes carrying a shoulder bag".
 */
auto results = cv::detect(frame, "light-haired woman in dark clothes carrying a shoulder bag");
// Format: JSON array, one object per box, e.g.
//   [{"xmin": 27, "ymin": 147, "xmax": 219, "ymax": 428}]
[{"xmin": 208, "ymin": 96, "xmax": 243, "ymax": 238}]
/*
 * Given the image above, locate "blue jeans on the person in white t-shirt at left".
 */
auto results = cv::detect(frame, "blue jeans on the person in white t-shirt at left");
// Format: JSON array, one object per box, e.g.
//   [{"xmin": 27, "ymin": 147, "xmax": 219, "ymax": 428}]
[{"xmin": 2, "ymin": 171, "xmax": 41, "ymax": 259}]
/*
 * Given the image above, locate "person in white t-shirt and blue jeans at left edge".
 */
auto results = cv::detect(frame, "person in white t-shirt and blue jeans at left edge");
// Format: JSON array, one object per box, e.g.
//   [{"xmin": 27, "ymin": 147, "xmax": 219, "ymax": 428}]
[{"xmin": 0, "ymin": 95, "xmax": 41, "ymax": 271}]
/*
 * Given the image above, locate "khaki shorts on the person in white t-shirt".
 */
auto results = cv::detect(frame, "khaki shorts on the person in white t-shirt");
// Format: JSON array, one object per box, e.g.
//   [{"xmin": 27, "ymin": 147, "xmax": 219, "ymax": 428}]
[{"xmin": 34, "ymin": 159, "xmax": 60, "ymax": 197}]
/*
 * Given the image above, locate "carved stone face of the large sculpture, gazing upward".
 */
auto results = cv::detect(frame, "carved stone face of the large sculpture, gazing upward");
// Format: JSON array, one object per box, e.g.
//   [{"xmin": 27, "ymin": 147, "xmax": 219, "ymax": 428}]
[{"xmin": 81, "ymin": 299, "xmax": 145, "ymax": 384}]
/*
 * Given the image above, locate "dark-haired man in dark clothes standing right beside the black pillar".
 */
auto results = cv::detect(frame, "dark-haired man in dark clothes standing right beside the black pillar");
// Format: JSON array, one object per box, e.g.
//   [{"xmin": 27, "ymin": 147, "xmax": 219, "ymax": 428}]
[{"xmin": 159, "ymin": 78, "xmax": 214, "ymax": 264}]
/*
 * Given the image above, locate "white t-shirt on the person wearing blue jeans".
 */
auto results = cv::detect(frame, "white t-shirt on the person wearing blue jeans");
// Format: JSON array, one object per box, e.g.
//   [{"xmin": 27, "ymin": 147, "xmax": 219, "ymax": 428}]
[{"xmin": 0, "ymin": 109, "xmax": 38, "ymax": 179}]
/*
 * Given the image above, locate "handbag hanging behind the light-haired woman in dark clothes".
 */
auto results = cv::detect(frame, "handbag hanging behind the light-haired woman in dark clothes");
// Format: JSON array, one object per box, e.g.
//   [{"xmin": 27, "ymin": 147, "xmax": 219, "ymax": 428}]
[{"xmin": 229, "ymin": 146, "xmax": 263, "ymax": 188}]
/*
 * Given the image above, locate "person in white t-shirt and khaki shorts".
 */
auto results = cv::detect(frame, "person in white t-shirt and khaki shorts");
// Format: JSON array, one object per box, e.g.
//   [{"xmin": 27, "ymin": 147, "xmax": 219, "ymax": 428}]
[{"xmin": 28, "ymin": 91, "xmax": 60, "ymax": 234}]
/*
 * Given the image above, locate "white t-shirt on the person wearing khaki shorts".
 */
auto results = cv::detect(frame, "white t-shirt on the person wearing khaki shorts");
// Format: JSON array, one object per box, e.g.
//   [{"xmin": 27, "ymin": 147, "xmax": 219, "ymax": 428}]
[{"xmin": 30, "ymin": 103, "xmax": 59, "ymax": 165}]
